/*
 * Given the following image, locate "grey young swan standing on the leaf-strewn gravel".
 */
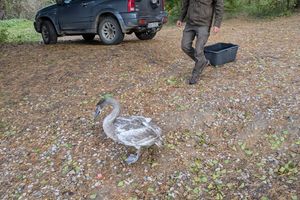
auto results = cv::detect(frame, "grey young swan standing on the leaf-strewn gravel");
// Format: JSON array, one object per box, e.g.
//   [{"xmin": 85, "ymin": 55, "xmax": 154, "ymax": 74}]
[{"xmin": 94, "ymin": 97, "xmax": 163, "ymax": 164}]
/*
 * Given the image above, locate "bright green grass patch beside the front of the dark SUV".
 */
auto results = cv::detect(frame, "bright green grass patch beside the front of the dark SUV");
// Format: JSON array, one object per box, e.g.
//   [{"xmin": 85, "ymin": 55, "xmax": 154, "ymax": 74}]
[{"xmin": 0, "ymin": 19, "xmax": 41, "ymax": 44}]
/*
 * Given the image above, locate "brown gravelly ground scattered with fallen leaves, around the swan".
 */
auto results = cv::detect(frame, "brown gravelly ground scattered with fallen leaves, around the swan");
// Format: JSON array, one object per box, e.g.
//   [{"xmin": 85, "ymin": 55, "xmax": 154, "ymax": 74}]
[{"xmin": 0, "ymin": 15, "xmax": 300, "ymax": 200}]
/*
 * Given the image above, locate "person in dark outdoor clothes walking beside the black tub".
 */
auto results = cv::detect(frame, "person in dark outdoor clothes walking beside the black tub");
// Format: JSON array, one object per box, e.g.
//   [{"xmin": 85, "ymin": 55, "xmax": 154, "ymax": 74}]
[{"xmin": 177, "ymin": 0, "xmax": 224, "ymax": 84}]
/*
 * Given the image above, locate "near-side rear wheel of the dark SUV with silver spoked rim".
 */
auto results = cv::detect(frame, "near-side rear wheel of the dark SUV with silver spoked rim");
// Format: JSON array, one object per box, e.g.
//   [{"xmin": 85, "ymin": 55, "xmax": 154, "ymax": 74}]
[{"xmin": 98, "ymin": 17, "xmax": 124, "ymax": 45}]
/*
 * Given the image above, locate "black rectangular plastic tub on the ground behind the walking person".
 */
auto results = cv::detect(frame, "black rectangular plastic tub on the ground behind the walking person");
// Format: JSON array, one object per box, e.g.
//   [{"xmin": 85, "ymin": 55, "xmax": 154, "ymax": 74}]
[{"xmin": 204, "ymin": 43, "xmax": 239, "ymax": 66}]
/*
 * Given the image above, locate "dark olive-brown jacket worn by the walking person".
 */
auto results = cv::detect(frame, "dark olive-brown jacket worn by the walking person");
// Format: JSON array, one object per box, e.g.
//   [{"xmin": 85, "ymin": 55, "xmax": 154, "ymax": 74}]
[{"xmin": 179, "ymin": 0, "xmax": 224, "ymax": 27}]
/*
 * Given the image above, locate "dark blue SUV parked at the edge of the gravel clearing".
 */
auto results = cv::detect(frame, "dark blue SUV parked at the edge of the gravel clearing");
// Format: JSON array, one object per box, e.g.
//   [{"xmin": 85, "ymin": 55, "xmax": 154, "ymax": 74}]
[{"xmin": 34, "ymin": 0, "xmax": 167, "ymax": 45}]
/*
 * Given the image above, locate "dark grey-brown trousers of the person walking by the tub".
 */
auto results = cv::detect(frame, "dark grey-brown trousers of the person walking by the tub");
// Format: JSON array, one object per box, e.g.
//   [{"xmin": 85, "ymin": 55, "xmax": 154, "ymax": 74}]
[{"xmin": 181, "ymin": 23, "xmax": 209, "ymax": 75}]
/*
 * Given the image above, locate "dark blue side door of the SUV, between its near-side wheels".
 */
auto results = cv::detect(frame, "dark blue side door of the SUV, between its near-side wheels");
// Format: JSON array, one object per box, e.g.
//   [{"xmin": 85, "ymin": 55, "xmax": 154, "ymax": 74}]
[{"xmin": 58, "ymin": 0, "xmax": 95, "ymax": 31}]
